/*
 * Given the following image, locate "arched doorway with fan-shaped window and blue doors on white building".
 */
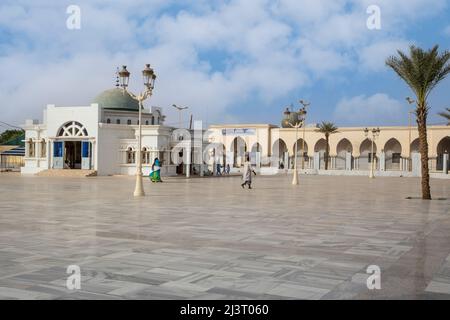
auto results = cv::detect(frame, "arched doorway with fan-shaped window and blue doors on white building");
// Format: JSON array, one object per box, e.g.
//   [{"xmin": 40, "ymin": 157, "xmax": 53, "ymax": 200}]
[{"xmin": 52, "ymin": 121, "xmax": 92, "ymax": 169}]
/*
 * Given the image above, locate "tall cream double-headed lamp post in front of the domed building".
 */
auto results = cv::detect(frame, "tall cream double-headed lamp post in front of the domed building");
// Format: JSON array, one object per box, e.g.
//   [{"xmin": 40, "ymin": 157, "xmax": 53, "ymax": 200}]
[{"xmin": 119, "ymin": 64, "xmax": 156, "ymax": 197}]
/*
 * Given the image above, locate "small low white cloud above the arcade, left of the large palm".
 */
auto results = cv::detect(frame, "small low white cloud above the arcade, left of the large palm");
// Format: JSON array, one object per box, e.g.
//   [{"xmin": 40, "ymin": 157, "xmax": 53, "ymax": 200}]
[{"xmin": 334, "ymin": 93, "xmax": 407, "ymax": 126}]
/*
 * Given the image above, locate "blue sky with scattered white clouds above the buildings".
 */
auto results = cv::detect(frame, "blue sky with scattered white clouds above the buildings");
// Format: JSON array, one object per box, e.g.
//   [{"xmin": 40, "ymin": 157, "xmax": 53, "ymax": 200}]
[{"xmin": 0, "ymin": 0, "xmax": 450, "ymax": 131}]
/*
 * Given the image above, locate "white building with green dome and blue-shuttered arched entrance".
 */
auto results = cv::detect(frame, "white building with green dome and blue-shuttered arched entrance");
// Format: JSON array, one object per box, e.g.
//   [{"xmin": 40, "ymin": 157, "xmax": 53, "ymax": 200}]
[{"xmin": 22, "ymin": 88, "xmax": 176, "ymax": 175}]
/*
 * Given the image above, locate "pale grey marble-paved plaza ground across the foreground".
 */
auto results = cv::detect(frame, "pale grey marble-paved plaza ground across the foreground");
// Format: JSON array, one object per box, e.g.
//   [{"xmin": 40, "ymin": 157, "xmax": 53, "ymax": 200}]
[{"xmin": 0, "ymin": 174, "xmax": 450, "ymax": 299}]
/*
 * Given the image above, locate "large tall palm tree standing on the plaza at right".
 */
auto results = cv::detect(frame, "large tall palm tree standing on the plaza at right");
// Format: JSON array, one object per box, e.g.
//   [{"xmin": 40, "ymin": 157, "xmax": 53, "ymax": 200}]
[{"xmin": 386, "ymin": 45, "xmax": 450, "ymax": 200}]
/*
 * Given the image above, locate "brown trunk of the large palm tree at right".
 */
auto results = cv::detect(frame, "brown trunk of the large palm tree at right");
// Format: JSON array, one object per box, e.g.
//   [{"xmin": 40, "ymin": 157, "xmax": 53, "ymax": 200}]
[{"xmin": 417, "ymin": 103, "xmax": 431, "ymax": 200}]
